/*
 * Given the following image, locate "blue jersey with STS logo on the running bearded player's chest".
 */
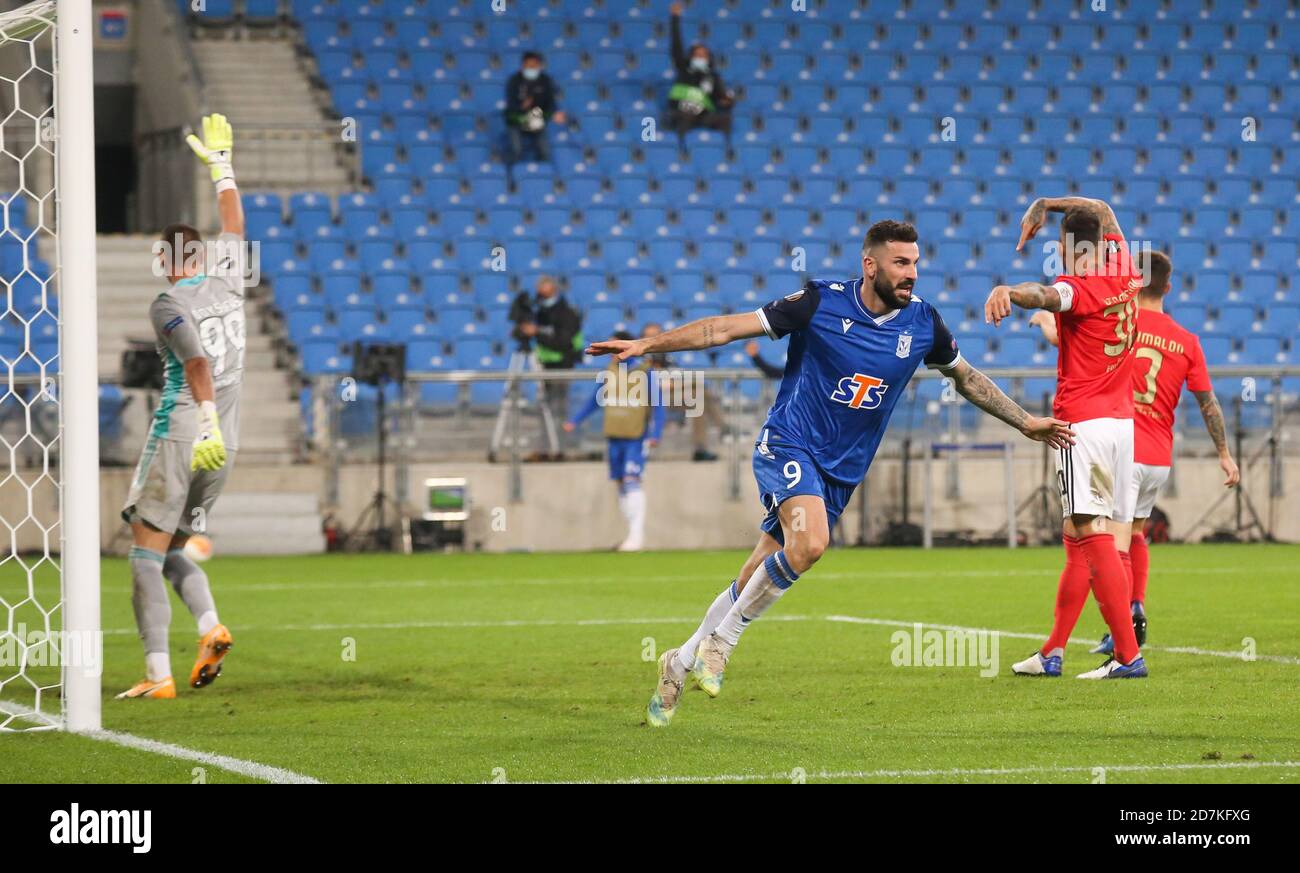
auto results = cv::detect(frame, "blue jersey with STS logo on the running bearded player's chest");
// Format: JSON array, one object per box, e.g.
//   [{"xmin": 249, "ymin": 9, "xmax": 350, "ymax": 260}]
[{"xmin": 757, "ymin": 279, "xmax": 961, "ymax": 485}]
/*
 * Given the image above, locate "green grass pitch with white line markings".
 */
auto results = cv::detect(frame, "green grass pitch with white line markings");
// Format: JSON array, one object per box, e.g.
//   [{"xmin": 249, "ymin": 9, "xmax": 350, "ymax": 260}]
[{"xmin": 0, "ymin": 546, "xmax": 1300, "ymax": 782}]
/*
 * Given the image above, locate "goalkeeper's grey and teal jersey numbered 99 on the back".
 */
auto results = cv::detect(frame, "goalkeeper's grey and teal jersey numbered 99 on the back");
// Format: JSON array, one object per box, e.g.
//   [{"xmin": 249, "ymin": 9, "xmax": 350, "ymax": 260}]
[{"xmin": 150, "ymin": 240, "xmax": 244, "ymax": 451}]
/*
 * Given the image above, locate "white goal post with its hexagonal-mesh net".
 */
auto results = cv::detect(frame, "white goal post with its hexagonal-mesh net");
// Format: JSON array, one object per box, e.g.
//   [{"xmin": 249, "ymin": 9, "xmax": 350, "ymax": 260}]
[{"xmin": 0, "ymin": 0, "xmax": 103, "ymax": 731}]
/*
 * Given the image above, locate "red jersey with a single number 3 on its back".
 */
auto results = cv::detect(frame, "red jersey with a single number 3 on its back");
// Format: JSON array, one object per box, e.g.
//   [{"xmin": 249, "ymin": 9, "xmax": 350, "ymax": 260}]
[{"xmin": 1132, "ymin": 309, "xmax": 1212, "ymax": 466}]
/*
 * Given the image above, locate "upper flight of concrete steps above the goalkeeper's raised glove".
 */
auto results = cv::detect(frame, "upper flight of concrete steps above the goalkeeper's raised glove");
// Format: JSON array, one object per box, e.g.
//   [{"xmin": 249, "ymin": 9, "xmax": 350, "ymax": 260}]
[{"xmin": 192, "ymin": 37, "xmax": 352, "ymax": 194}]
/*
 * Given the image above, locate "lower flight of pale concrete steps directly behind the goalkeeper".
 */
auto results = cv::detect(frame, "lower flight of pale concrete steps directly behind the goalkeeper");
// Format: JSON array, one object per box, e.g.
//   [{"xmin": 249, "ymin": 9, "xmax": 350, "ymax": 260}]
[{"xmin": 98, "ymin": 236, "xmax": 302, "ymax": 465}]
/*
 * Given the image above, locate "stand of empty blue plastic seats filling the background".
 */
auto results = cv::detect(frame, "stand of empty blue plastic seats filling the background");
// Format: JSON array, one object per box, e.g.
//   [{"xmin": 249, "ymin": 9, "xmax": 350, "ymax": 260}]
[{"xmin": 181, "ymin": 0, "xmax": 1300, "ymax": 418}]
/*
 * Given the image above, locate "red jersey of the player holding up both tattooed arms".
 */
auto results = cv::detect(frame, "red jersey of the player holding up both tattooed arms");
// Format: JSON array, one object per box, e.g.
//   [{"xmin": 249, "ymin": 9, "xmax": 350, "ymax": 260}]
[{"xmin": 1053, "ymin": 234, "xmax": 1141, "ymax": 422}]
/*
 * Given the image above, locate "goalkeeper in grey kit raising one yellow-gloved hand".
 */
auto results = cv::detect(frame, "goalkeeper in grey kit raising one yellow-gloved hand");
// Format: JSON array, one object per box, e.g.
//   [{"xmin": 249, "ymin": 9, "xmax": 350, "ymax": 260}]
[{"xmin": 117, "ymin": 114, "xmax": 244, "ymax": 699}]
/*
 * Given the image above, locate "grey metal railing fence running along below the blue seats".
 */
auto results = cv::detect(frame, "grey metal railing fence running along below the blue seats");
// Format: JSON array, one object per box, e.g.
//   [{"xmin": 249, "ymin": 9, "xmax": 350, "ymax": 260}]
[{"xmin": 308, "ymin": 365, "xmax": 1300, "ymax": 544}]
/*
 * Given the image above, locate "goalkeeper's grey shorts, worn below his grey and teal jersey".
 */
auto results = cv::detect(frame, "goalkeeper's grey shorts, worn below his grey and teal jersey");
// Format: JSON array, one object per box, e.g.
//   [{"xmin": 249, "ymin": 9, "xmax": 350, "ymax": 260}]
[{"xmin": 122, "ymin": 437, "xmax": 235, "ymax": 534}]
